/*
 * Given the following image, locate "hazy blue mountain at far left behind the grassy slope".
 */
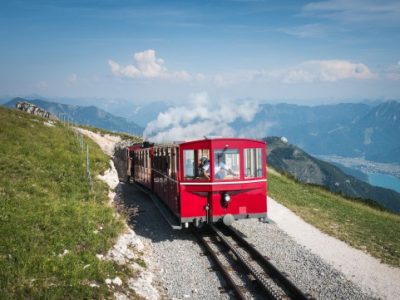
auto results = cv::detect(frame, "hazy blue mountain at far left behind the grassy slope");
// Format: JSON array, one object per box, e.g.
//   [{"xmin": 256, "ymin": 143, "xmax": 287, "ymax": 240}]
[{"xmin": 4, "ymin": 98, "xmax": 143, "ymax": 135}]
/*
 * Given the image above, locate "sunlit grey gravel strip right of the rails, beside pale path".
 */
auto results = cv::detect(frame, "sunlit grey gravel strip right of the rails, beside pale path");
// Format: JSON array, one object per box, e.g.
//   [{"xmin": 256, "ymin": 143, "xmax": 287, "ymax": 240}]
[{"xmin": 233, "ymin": 220, "xmax": 374, "ymax": 299}]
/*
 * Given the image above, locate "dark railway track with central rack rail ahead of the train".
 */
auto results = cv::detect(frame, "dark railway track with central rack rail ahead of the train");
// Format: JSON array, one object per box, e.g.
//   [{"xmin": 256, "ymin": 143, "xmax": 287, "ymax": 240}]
[{"xmin": 194, "ymin": 225, "xmax": 309, "ymax": 299}]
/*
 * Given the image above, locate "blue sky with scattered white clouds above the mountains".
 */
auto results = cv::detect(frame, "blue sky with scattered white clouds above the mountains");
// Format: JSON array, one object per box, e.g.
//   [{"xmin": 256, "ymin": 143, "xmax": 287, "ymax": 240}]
[{"xmin": 0, "ymin": 0, "xmax": 400, "ymax": 104}]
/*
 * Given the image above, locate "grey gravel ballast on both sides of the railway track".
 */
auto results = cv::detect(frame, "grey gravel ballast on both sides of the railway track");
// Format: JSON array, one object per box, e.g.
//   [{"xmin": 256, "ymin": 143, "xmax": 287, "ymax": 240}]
[{"xmin": 118, "ymin": 179, "xmax": 373, "ymax": 299}]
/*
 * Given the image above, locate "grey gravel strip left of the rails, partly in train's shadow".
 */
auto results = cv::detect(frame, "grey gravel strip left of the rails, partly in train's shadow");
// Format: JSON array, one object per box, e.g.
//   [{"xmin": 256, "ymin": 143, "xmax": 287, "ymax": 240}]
[{"xmin": 118, "ymin": 184, "xmax": 232, "ymax": 299}]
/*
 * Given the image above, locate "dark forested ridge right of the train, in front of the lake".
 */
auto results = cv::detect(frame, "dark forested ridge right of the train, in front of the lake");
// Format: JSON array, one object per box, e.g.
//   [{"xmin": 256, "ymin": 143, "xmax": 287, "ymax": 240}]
[{"xmin": 265, "ymin": 137, "xmax": 400, "ymax": 213}]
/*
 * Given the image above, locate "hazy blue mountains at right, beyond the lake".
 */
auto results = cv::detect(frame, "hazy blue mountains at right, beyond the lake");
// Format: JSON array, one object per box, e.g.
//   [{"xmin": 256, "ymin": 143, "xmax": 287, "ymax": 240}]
[{"xmin": 239, "ymin": 101, "xmax": 400, "ymax": 163}]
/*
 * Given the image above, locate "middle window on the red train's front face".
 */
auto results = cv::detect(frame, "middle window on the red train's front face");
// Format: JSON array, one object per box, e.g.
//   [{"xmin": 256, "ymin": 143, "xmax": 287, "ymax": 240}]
[{"xmin": 214, "ymin": 149, "xmax": 240, "ymax": 180}]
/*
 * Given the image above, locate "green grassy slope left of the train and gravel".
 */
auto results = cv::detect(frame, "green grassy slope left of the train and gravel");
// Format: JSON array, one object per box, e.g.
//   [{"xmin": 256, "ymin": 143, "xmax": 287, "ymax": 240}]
[{"xmin": 0, "ymin": 108, "xmax": 128, "ymax": 299}]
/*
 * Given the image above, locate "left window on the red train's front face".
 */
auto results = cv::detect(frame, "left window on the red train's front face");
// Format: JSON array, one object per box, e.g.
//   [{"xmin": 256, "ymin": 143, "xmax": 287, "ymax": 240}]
[{"xmin": 183, "ymin": 149, "xmax": 210, "ymax": 180}]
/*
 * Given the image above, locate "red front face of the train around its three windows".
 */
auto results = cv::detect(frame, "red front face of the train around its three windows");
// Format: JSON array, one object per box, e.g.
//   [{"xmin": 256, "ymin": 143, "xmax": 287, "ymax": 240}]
[{"xmin": 180, "ymin": 138, "xmax": 267, "ymax": 223}]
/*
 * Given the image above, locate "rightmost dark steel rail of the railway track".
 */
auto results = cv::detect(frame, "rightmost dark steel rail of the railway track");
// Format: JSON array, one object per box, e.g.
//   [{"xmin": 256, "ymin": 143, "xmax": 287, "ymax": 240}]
[{"xmin": 223, "ymin": 225, "xmax": 310, "ymax": 300}]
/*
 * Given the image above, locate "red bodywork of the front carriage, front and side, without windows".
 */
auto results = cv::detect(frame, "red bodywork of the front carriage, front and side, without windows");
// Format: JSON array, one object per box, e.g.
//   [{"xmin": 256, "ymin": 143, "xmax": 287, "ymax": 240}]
[{"xmin": 133, "ymin": 138, "xmax": 267, "ymax": 224}]
